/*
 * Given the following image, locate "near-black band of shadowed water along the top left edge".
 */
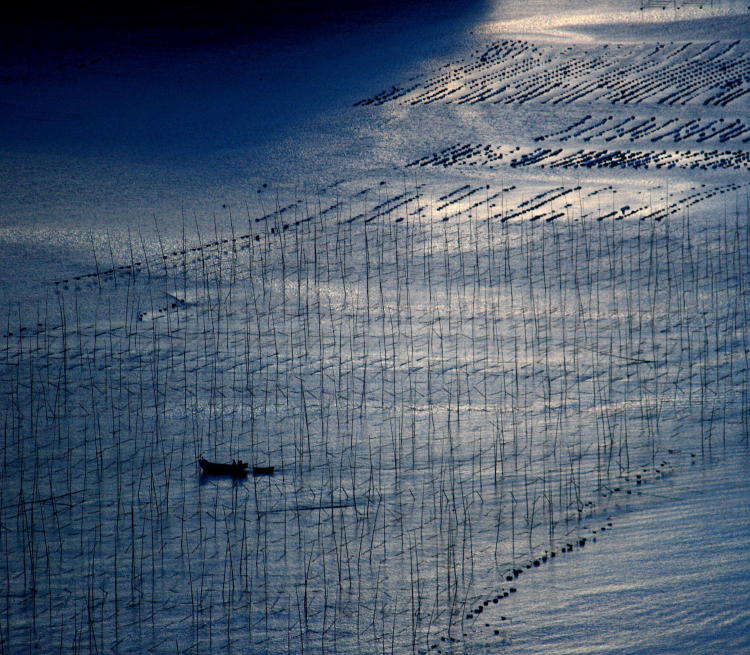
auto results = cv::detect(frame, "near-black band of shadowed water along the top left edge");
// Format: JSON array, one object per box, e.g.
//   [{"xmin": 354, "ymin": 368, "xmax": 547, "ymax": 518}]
[{"xmin": 0, "ymin": 0, "xmax": 492, "ymax": 80}]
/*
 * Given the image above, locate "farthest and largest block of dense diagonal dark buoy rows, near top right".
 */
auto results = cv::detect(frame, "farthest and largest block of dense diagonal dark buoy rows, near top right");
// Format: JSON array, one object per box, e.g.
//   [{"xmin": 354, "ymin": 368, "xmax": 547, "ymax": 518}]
[{"xmin": 356, "ymin": 36, "xmax": 750, "ymax": 109}]
